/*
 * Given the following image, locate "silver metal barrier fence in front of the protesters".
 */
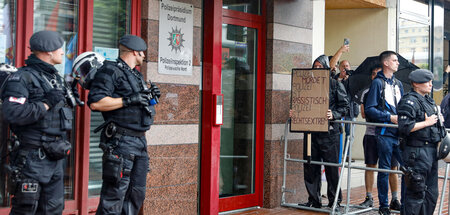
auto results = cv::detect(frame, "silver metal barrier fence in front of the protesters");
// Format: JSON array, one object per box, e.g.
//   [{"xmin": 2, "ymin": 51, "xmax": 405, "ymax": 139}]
[{"xmin": 281, "ymin": 119, "xmax": 450, "ymax": 214}]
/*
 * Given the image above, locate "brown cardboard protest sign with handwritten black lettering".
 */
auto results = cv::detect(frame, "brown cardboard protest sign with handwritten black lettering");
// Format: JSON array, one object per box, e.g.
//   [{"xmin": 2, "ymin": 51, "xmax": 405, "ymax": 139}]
[{"xmin": 291, "ymin": 69, "xmax": 330, "ymax": 132}]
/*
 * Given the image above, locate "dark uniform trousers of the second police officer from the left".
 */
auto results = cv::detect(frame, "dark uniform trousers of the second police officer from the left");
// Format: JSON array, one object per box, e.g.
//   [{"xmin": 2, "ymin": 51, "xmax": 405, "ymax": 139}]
[{"xmin": 96, "ymin": 135, "xmax": 149, "ymax": 215}]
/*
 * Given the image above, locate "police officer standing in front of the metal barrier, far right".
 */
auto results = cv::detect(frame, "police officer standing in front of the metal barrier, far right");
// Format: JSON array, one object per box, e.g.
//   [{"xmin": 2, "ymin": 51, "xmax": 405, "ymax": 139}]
[{"xmin": 398, "ymin": 69, "xmax": 444, "ymax": 215}]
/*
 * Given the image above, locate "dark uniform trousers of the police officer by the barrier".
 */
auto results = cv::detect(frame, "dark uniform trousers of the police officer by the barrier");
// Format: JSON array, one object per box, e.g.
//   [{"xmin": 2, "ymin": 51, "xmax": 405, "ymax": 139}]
[{"xmin": 402, "ymin": 144, "xmax": 439, "ymax": 215}]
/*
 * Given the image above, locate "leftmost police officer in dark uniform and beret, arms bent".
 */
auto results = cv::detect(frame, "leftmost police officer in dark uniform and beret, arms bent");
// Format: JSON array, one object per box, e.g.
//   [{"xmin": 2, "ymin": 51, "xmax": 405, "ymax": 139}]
[{"xmin": 2, "ymin": 31, "xmax": 73, "ymax": 214}]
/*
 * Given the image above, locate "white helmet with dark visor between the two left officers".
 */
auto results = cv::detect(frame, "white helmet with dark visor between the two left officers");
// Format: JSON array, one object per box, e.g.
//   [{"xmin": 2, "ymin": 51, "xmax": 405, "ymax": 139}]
[{"xmin": 72, "ymin": 52, "xmax": 105, "ymax": 89}]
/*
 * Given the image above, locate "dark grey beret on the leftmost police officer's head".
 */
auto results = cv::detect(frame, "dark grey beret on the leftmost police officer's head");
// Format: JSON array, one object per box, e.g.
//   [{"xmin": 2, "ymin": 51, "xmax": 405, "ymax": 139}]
[{"xmin": 30, "ymin": 31, "xmax": 64, "ymax": 52}]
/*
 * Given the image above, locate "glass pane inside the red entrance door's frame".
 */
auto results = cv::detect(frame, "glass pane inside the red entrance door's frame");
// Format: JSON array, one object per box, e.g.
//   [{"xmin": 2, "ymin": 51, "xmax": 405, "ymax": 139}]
[{"xmin": 219, "ymin": 24, "xmax": 257, "ymax": 197}]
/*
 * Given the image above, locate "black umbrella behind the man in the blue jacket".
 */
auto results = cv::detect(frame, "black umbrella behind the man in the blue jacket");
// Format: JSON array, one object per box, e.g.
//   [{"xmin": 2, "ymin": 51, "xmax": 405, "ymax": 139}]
[{"xmin": 348, "ymin": 55, "xmax": 419, "ymax": 98}]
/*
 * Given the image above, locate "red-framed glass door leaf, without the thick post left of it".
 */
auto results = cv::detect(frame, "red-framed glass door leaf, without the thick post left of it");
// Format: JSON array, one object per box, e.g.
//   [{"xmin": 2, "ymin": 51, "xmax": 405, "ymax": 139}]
[{"xmin": 219, "ymin": 17, "xmax": 264, "ymax": 211}]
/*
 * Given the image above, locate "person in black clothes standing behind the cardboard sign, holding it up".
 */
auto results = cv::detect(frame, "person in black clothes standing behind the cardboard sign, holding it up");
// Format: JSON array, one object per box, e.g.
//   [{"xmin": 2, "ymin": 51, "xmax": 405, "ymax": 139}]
[{"xmin": 299, "ymin": 55, "xmax": 348, "ymax": 208}]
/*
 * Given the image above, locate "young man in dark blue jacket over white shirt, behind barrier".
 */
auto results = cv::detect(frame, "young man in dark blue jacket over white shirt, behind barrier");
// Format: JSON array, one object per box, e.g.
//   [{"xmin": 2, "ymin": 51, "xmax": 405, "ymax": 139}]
[{"xmin": 364, "ymin": 51, "xmax": 403, "ymax": 214}]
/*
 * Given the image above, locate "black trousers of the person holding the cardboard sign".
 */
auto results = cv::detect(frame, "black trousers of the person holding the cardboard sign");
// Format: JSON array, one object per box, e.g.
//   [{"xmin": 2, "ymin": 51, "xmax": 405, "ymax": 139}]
[{"xmin": 303, "ymin": 133, "xmax": 342, "ymax": 205}]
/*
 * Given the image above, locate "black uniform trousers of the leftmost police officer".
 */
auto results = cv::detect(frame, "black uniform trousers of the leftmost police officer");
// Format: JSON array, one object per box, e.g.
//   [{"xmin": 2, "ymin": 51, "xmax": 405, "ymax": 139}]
[{"xmin": 11, "ymin": 146, "xmax": 65, "ymax": 215}]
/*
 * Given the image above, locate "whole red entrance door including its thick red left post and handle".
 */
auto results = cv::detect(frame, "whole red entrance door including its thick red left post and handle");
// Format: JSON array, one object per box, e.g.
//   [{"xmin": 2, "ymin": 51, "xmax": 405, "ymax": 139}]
[{"xmin": 200, "ymin": 0, "xmax": 266, "ymax": 214}]
